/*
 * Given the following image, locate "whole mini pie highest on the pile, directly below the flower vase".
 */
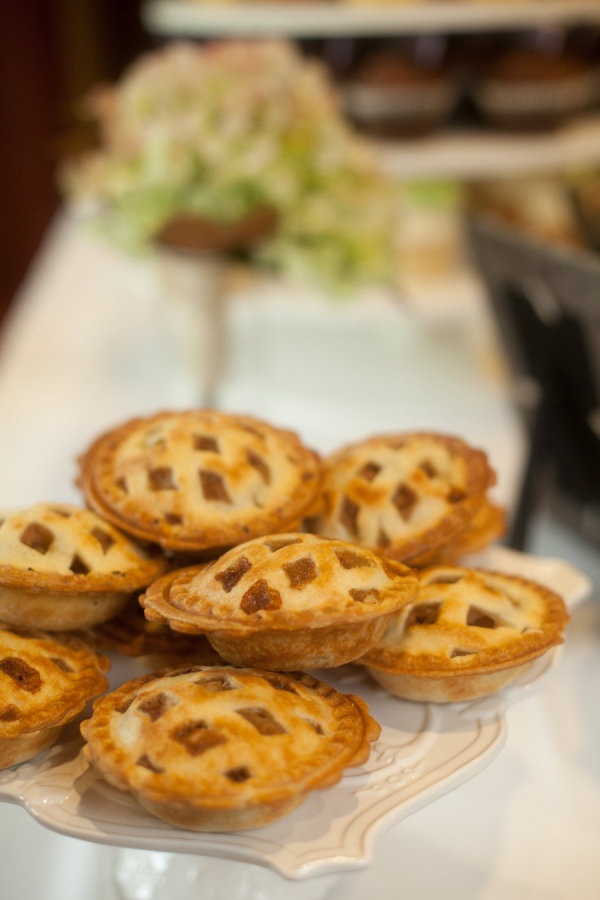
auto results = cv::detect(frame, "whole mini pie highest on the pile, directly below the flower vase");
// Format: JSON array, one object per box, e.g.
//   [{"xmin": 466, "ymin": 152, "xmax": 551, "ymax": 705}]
[{"xmin": 79, "ymin": 409, "xmax": 322, "ymax": 558}]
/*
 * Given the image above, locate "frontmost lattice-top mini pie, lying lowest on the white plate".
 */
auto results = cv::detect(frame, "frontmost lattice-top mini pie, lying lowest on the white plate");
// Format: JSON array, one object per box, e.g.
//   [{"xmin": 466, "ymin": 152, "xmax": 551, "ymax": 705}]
[{"xmin": 81, "ymin": 666, "xmax": 380, "ymax": 831}]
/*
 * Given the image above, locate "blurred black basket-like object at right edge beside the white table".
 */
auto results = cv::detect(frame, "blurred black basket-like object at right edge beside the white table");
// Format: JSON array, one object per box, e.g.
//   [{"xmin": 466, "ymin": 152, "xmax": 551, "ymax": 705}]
[{"xmin": 466, "ymin": 215, "xmax": 600, "ymax": 550}]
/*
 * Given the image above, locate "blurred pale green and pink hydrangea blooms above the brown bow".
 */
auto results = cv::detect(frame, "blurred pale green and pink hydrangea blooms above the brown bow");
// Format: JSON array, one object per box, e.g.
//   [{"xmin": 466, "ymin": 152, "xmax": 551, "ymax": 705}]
[{"xmin": 61, "ymin": 41, "xmax": 397, "ymax": 288}]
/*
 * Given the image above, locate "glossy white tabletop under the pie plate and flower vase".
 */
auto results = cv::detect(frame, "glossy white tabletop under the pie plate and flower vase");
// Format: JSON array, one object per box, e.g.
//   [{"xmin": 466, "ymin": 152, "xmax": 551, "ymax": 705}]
[{"xmin": 0, "ymin": 215, "xmax": 600, "ymax": 900}]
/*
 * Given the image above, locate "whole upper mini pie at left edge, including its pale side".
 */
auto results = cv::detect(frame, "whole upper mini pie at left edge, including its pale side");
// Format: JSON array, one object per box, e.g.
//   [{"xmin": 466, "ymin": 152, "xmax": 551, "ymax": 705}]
[{"xmin": 0, "ymin": 503, "xmax": 167, "ymax": 631}]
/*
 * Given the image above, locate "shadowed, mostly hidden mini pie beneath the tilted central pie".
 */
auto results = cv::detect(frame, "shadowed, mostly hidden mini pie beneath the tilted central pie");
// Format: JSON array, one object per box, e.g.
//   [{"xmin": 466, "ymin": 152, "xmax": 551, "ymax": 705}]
[{"xmin": 80, "ymin": 563, "xmax": 223, "ymax": 669}]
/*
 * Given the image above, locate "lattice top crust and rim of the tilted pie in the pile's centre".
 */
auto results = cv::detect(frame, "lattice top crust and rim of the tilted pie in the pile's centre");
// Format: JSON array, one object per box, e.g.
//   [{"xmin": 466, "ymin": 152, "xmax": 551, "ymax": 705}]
[{"xmin": 140, "ymin": 532, "xmax": 418, "ymax": 636}]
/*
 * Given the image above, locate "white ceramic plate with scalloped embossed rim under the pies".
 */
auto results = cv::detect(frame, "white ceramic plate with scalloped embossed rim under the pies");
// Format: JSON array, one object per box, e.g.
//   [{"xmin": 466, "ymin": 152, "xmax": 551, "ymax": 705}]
[{"xmin": 0, "ymin": 549, "xmax": 590, "ymax": 878}]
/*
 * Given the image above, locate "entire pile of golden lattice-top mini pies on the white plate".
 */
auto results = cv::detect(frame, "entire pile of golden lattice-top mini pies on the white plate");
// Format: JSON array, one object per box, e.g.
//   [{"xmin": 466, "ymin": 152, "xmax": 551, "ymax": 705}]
[{"xmin": 0, "ymin": 409, "xmax": 568, "ymax": 831}]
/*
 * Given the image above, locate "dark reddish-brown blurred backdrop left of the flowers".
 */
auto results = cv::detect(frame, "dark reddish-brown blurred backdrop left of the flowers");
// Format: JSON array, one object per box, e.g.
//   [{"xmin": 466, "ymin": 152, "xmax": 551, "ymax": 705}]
[{"xmin": 0, "ymin": 0, "xmax": 153, "ymax": 324}]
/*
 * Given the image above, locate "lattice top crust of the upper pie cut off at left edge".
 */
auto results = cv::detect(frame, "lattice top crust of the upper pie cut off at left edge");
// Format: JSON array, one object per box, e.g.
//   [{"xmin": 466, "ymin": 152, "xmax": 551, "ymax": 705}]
[{"xmin": 0, "ymin": 503, "xmax": 166, "ymax": 595}]
